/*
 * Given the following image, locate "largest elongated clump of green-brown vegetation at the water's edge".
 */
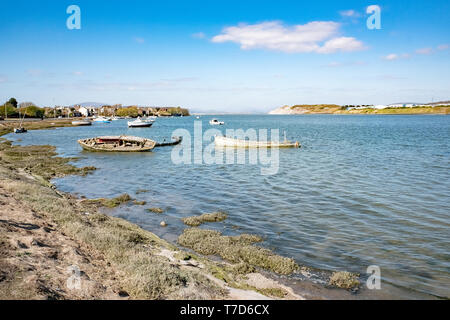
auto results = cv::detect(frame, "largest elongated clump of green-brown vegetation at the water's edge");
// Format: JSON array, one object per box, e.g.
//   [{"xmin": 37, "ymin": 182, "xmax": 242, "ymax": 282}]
[{"xmin": 178, "ymin": 228, "xmax": 299, "ymax": 274}]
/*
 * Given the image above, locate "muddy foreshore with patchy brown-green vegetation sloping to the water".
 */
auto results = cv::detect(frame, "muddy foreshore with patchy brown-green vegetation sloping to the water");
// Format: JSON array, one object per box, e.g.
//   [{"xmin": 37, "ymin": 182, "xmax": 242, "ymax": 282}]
[{"xmin": 0, "ymin": 120, "xmax": 358, "ymax": 299}]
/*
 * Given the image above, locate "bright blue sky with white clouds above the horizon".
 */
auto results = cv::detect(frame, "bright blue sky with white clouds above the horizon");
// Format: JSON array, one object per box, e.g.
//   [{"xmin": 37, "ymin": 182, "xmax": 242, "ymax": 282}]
[{"xmin": 0, "ymin": 0, "xmax": 450, "ymax": 112}]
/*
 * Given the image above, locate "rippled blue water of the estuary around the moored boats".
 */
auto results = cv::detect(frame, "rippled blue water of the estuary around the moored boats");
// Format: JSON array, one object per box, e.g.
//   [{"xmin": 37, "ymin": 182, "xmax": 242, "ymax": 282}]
[{"xmin": 9, "ymin": 115, "xmax": 450, "ymax": 297}]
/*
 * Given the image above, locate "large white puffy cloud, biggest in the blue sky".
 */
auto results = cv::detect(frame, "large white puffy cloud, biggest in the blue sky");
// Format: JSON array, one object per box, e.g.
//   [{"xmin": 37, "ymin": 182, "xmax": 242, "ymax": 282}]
[{"xmin": 212, "ymin": 21, "xmax": 364, "ymax": 53}]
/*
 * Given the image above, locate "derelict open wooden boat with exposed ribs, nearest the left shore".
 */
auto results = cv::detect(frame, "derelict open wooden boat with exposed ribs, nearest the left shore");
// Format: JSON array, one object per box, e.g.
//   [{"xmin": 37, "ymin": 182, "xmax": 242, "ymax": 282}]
[{"xmin": 78, "ymin": 136, "xmax": 156, "ymax": 152}]
